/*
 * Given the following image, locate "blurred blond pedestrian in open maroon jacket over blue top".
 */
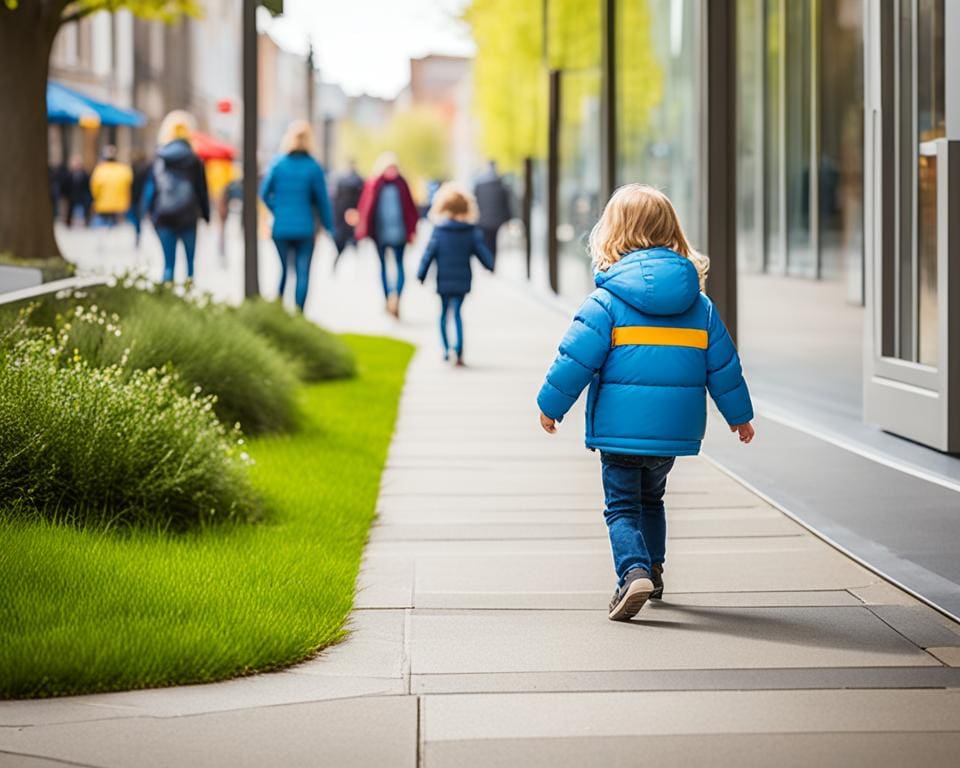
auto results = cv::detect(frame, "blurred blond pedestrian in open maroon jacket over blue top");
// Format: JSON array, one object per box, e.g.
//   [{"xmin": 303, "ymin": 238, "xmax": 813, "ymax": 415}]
[{"xmin": 356, "ymin": 152, "xmax": 420, "ymax": 317}]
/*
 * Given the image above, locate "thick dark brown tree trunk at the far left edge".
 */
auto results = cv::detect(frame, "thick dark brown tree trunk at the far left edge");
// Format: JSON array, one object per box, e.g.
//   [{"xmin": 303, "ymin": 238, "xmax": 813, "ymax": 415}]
[{"xmin": 0, "ymin": 2, "xmax": 61, "ymax": 261}]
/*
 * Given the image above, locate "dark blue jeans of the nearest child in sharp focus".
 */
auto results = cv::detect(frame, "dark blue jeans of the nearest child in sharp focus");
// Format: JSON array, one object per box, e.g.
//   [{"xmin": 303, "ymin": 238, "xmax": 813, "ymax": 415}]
[{"xmin": 600, "ymin": 453, "xmax": 675, "ymax": 585}]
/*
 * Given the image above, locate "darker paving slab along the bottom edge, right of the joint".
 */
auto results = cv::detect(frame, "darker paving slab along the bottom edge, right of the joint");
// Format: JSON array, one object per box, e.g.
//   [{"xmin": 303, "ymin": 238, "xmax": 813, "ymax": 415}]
[{"xmin": 423, "ymin": 733, "xmax": 960, "ymax": 768}]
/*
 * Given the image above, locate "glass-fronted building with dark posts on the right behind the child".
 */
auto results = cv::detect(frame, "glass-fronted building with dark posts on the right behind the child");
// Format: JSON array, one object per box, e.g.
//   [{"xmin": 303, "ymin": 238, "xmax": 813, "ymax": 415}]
[{"xmin": 529, "ymin": 0, "xmax": 960, "ymax": 452}]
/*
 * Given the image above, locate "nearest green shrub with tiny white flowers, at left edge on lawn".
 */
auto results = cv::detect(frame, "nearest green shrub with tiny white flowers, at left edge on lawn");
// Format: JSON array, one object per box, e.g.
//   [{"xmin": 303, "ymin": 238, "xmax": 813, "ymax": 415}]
[{"xmin": 0, "ymin": 323, "xmax": 259, "ymax": 528}]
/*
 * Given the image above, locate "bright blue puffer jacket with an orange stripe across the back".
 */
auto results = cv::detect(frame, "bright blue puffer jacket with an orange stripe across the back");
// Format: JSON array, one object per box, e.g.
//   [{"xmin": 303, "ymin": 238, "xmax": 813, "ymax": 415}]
[{"xmin": 537, "ymin": 248, "xmax": 753, "ymax": 456}]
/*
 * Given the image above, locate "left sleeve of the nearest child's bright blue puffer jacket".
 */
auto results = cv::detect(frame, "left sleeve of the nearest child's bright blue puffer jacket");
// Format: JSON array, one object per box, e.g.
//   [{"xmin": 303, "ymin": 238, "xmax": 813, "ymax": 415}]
[{"xmin": 537, "ymin": 296, "xmax": 613, "ymax": 421}]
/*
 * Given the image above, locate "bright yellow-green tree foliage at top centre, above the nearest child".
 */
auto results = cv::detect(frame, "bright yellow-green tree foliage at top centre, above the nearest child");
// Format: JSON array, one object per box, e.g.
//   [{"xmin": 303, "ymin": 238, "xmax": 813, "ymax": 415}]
[{"xmin": 464, "ymin": 0, "xmax": 664, "ymax": 176}]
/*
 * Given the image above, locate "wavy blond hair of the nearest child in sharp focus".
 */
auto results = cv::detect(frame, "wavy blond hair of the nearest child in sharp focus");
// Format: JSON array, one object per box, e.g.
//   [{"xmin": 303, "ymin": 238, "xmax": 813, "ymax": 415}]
[{"xmin": 590, "ymin": 184, "xmax": 710, "ymax": 290}]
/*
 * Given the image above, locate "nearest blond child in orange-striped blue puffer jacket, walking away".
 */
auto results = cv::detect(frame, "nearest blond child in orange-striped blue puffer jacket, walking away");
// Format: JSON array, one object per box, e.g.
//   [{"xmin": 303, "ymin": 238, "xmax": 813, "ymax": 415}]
[{"xmin": 537, "ymin": 184, "xmax": 754, "ymax": 621}]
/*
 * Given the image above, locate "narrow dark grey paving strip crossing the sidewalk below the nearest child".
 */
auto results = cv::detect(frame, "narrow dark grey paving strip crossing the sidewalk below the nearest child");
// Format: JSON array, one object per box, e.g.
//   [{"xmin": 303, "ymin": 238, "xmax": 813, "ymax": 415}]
[{"xmin": 410, "ymin": 666, "xmax": 960, "ymax": 695}]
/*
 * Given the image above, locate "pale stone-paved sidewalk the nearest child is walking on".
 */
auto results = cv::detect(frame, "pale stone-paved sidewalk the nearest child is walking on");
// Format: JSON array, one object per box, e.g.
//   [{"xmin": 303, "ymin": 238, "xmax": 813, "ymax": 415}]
[{"xmin": 0, "ymin": 242, "xmax": 960, "ymax": 768}]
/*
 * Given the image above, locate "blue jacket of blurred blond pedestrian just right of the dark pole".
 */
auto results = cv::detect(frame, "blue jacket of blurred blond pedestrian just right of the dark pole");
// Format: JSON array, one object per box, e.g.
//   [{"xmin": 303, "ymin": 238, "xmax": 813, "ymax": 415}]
[{"xmin": 260, "ymin": 152, "xmax": 333, "ymax": 240}]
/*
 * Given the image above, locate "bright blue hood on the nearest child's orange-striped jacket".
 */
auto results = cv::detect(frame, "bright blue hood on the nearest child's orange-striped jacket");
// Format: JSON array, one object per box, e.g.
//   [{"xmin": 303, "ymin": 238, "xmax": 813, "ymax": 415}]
[{"xmin": 595, "ymin": 248, "xmax": 700, "ymax": 315}]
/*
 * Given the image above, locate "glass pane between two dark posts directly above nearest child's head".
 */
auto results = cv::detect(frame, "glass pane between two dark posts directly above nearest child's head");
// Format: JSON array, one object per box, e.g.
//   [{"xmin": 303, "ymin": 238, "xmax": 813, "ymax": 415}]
[{"xmin": 616, "ymin": 0, "xmax": 703, "ymax": 247}]
